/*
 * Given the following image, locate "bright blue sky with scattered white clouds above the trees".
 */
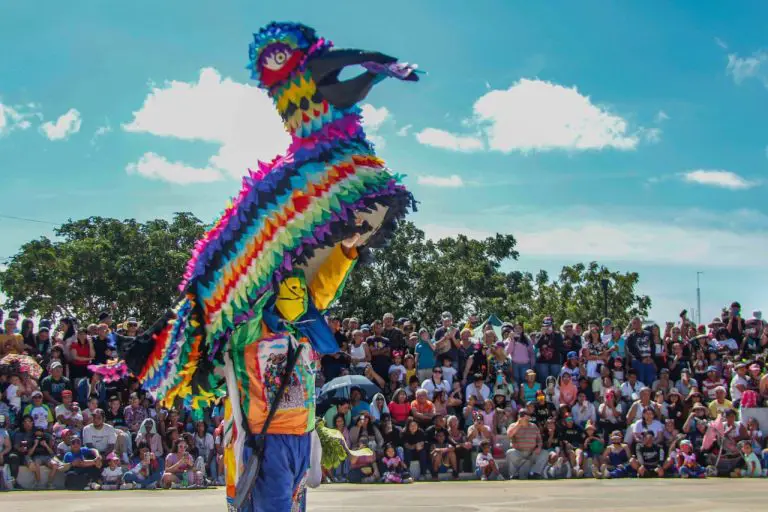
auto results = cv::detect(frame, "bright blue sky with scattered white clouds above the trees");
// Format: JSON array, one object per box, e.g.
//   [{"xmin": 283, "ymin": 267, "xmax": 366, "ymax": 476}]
[{"xmin": 0, "ymin": 0, "xmax": 768, "ymax": 320}]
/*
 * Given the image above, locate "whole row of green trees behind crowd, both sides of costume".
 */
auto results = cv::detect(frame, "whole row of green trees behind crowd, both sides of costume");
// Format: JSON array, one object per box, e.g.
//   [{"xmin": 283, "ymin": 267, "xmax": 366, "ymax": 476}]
[{"xmin": 0, "ymin": 213, "xmax": 651, "ymax": 328}]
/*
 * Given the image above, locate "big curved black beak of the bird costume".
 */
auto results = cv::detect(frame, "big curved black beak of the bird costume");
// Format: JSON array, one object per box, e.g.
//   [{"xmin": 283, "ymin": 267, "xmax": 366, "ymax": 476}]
[{"xmin": 307, "ymin": 50, "xmax": 397, "ymax": 109}]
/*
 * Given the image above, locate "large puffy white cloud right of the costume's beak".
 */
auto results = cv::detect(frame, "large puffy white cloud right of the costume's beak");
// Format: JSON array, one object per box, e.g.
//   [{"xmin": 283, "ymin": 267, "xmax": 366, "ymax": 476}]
[{"xmin": 474, "ymin": 79, "xmax": 639, "ymax": 153}]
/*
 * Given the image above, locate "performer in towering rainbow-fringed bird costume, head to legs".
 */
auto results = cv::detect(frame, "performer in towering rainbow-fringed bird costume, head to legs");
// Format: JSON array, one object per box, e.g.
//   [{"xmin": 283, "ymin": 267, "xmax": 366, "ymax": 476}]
[{"xmin": 121, "ymin": 23, "xmax": 418, "ymax": 512}]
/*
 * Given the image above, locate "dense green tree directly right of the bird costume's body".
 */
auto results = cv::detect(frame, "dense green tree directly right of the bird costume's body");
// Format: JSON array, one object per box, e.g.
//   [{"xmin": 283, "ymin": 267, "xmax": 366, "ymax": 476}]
[{"xmin": 338, "ymin": 222, "xmax": 518, "ymax": 325}]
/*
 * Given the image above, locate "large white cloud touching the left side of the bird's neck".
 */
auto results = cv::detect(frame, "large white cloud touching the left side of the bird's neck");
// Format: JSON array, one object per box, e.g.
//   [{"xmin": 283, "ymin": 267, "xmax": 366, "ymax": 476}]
[{"xmin": 122, "ymin": 68, "xmax": 291, "ymax": 181}]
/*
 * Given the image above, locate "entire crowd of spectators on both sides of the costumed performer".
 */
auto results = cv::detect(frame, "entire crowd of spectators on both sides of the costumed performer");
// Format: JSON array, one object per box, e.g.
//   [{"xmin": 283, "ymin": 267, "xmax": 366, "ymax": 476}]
[{"xmin": 0, "ymin": 303, "xmax": 768, "ymax": 489}]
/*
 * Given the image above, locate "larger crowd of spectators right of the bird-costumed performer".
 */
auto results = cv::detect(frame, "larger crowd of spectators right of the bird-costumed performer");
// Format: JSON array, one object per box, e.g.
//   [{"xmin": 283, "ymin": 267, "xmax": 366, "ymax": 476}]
[{"xmin": 318, "ymin": 302, "xmax": 768, "ymax": 483}]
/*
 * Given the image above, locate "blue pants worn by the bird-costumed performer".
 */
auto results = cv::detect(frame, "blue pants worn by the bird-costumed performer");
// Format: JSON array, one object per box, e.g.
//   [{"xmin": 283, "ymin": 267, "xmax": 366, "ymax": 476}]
[{"xmin": 240, "ymin": 434, "xmax": 312, "ymax": 512}]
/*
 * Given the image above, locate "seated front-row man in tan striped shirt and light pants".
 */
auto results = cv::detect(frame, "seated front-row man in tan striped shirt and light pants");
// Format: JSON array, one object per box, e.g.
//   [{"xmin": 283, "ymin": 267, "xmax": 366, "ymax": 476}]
[{"xmin": 507, "ymin": 410, "xmax": 546, "ymax": 480}]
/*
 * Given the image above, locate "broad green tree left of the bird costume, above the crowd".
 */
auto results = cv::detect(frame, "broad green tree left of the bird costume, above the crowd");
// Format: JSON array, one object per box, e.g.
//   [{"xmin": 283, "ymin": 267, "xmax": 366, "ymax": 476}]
[{"xmin": 0, "ymin": 213, "xmax": 204, "ymax": 322}]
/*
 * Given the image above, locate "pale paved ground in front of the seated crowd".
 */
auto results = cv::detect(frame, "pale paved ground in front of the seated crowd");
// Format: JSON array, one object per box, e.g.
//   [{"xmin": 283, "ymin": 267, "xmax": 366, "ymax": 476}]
[{"xmin": 0, "ymin": 479, "xmax": 768, "ymax": 512}]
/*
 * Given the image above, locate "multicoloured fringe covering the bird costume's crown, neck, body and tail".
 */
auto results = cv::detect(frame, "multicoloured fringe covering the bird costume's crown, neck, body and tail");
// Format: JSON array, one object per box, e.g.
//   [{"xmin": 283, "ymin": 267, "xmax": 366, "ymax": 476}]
[{"xmin": 124, "ymin": 24, "xmax": 415, "ymax": 418}]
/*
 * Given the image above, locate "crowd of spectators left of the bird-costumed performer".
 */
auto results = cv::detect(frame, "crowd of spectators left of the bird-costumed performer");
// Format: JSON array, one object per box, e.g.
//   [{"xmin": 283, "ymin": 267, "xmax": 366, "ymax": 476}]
[{"xmin": 0, "ymin": 310, "xmax": 224, "ymax": 490}]
